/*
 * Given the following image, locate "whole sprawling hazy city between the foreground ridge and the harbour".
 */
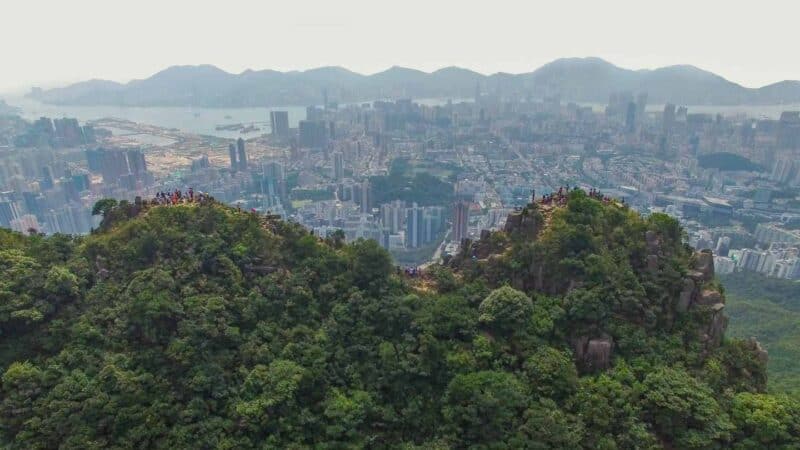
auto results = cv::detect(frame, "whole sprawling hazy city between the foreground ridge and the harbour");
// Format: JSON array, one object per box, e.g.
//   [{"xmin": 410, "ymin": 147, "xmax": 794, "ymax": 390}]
[{"xmin": 0, "ymin": 86, "xmax": 800, "ymax": 270}]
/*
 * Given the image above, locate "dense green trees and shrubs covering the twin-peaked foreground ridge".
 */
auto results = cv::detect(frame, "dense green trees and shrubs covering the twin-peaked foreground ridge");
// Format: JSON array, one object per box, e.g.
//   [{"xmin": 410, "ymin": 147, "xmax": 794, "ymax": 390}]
[{"xmin": 0, "ymin": 198, "xmax": 800, "ymax": 449}]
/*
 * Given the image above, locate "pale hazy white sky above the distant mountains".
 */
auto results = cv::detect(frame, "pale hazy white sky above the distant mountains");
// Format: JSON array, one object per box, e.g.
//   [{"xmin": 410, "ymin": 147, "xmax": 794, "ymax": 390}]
[{"xmin": 0, "ymin": 0, "xmax": 800, "ymax": 90}]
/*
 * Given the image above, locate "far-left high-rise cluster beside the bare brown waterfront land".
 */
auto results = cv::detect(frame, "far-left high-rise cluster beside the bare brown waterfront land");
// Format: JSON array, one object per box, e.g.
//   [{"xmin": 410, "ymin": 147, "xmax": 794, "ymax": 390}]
[{"xmin": 0, "ymin": 117, "xmax": 155, "ymax": 234}]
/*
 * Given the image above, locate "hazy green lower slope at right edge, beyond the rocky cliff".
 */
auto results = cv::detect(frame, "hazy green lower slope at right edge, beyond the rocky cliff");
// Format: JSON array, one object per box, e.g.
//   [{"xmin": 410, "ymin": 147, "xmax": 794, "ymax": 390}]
[{"xmin": 722, "ymin": 272, "xmax": 800, "ymax": 397}]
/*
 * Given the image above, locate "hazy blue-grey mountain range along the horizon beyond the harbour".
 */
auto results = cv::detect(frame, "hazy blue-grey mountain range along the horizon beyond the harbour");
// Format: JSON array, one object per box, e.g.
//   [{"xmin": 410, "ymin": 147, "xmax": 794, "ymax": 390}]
[{"xmin": 30, "ymin": 58, "xmax": 800, "ymax": 107}]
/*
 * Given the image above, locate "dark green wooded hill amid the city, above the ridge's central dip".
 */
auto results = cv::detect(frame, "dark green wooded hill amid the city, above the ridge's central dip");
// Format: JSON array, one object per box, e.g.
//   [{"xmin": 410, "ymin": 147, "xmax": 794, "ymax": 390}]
[{"xmin": 369, "ymin": 159, "xmax": 453, "ymax": 206}]
